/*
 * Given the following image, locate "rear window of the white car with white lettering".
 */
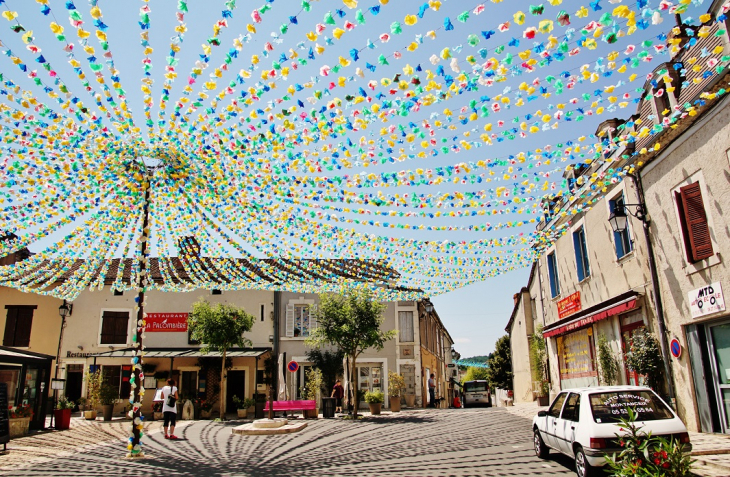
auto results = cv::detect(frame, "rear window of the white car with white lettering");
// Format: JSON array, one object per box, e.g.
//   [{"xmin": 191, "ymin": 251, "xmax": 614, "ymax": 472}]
[{"xmin": 590, "ymin": 390, "xmax": 674, "ymax": 424}]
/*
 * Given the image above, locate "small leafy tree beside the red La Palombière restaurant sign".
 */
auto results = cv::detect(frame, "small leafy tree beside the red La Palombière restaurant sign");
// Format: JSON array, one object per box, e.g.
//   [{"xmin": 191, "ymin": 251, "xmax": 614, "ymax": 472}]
[{"xmin": 188, "ymin": 299, "xmax": 254, "ymax": 419}]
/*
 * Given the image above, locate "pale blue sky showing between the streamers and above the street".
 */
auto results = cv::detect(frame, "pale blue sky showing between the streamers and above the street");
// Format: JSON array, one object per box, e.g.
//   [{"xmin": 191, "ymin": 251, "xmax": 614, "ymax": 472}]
[{"xmin": 0, "ymin": 0, "xmax": 709, "ymax": 356}]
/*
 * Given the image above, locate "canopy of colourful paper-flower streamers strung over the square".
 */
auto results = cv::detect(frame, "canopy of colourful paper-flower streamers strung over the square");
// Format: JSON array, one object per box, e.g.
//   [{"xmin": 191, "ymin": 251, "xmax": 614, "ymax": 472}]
[{"xmin": 0, "ymin": 0, "xmax": 730, "ymax": 299}]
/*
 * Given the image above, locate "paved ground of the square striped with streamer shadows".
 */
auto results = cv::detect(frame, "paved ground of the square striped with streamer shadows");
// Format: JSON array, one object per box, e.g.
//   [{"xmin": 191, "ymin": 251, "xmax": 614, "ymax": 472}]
[{"xmin": 0, "ymin": 408, "xmax": 573, "ymax": 477}]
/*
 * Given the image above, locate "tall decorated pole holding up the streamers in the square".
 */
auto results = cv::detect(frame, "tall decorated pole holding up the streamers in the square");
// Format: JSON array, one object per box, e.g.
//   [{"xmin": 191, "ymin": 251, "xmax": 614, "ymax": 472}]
[{"xmin": 127, "ymin": 165, "xmax": 152, "ymax": 457}]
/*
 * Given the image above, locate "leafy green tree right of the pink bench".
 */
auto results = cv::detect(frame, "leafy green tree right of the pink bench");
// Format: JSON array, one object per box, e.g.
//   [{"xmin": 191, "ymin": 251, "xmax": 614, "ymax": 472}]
[{"xmin": 306, "ymin": 291, "xmax": 395, "ymax": 419}]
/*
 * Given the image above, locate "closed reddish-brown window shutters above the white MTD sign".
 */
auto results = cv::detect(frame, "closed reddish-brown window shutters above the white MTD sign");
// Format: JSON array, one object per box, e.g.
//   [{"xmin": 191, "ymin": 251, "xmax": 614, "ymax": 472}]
[{"xmin": 675, "ymin": 182, "xmax": 714, "ymax": 263}]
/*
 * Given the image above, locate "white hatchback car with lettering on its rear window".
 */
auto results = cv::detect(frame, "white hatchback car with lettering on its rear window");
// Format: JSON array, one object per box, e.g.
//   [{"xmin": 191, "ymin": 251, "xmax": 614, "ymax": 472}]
[{"xmin": 532, "ymin": 386, "xmax": 692, "ymax": 477}]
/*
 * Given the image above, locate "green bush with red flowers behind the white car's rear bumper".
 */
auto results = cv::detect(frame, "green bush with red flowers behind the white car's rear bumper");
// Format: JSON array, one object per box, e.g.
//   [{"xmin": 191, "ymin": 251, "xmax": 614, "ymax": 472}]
[{"xmin": 606, "ymin": 408, "xmax": 694, "ymax": 477}]
